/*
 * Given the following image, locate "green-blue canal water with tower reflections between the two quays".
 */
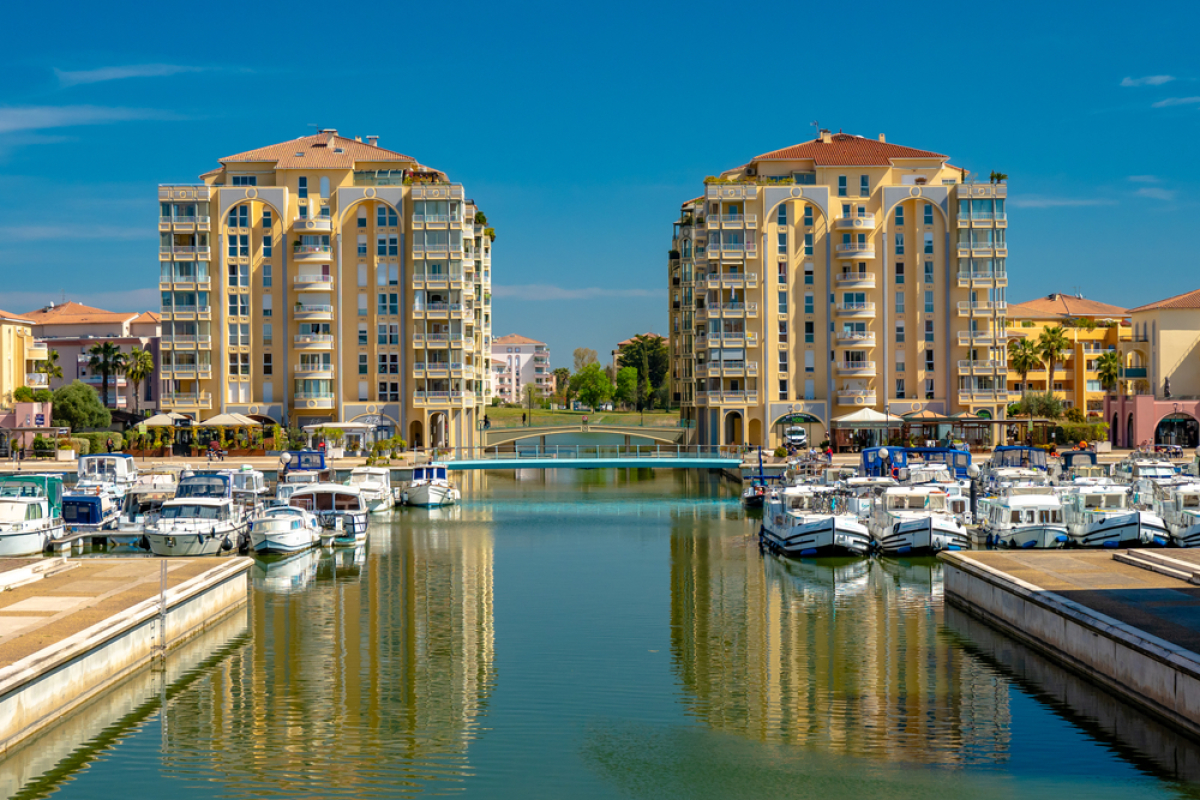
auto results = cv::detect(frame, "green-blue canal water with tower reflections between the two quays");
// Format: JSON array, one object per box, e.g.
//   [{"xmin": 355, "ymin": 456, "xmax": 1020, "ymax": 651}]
[{"xmin": 7, "ymin": 470, "xmax": 1200, "ymax": 800}]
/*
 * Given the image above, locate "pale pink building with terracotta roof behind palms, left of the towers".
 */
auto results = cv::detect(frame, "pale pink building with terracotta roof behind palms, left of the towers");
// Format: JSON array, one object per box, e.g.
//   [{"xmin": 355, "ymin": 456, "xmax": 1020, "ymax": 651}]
[{"xmin": 23, "ymin": 301, "xmax": 160, "ymax": 411}]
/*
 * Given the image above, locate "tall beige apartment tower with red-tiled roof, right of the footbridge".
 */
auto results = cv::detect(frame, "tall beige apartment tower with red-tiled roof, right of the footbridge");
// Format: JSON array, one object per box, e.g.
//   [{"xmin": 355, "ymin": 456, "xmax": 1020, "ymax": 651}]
[{"xmin": 670, "ymin": 131, "xmax": 1009, "ymax": 446}]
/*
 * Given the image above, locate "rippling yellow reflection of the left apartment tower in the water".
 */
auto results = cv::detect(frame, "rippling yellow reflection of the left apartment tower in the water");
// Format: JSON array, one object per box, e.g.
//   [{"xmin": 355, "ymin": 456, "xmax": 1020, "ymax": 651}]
[{"xmin": 163, "ymin": 512, "xmax": 494, "ymax": 796}]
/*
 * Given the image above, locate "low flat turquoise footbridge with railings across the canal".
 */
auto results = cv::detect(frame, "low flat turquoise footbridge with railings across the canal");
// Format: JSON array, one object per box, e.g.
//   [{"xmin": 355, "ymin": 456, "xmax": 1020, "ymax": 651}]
[{"xmin": 445, "ymin": 443, "xmax": 742, "ymax": 470}]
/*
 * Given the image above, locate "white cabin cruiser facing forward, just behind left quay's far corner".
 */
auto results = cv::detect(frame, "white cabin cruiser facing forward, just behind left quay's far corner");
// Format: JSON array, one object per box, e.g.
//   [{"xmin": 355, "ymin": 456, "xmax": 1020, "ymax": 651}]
[{"xmin": 145, "ymin": 470, "xmax": 248, "ymax": 555}]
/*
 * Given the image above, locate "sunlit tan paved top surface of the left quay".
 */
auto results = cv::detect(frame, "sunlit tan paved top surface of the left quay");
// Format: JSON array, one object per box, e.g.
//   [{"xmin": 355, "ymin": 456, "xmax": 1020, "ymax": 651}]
[{"xmin": 0, "ymin": 558, "xmax": 222, "ymax": 668}]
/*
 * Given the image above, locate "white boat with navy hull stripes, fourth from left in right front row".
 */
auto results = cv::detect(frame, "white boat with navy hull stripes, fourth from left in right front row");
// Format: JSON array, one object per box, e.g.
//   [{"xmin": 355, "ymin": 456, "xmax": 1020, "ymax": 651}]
[{"xmin": 1062, "ymin": 486, "xmax": 1170, "ymax": 547}]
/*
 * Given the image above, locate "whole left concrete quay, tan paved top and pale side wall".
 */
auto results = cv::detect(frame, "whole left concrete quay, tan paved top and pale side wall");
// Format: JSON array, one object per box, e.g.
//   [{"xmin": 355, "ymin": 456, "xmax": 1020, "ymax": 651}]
[{"xmin": 0, "ymin": 558, "xmax": 253, "ymax": 756}]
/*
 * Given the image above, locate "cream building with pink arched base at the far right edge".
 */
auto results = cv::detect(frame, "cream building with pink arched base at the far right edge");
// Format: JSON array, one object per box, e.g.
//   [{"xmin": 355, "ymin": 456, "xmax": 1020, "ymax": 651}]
[{"xmin": 1104, "ymin": 289, "xmax": 1200, "ymax": 447}]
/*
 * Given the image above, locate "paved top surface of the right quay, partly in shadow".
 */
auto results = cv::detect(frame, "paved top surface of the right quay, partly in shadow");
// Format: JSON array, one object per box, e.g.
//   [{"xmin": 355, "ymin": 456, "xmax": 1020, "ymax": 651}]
[{"xmin": 962, "ymin": 548, "xmax": 1200, "ymax": 654}]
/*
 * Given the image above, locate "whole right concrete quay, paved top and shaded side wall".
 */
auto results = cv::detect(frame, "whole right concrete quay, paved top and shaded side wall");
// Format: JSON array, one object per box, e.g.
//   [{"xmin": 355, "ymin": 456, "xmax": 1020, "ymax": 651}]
[{"xmin": 938, "ymin": 551, "xmax": 1200, "ymax": 739}]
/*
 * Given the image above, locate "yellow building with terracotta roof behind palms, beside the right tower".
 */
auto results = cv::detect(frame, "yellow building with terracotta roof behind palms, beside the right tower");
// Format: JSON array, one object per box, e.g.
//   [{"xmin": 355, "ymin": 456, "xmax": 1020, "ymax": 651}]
[{"xmin": 1008, "ymin": 294, "xmax": 1130, "ymax": 417}]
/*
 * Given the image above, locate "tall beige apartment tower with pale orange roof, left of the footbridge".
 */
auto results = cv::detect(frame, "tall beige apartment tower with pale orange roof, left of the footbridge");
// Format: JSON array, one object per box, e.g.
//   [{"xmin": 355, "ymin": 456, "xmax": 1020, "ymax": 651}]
[{"xmin": 158, "ymin": 130, "xmax": 493, "ymax": 446}]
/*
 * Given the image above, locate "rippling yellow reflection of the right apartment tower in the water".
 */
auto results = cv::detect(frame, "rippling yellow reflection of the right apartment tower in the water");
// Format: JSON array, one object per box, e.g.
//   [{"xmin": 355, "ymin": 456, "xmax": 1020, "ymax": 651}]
[{"xmin": 671, "ymin": 521, "xmax": 1010, "ymax": 765}]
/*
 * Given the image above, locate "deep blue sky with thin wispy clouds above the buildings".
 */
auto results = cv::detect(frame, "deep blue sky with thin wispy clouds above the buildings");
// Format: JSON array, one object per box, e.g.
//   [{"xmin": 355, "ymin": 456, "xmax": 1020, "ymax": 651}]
[{"xmin": 0, "ymin": 2, "xmax": 1200, "ymax": 366}]
